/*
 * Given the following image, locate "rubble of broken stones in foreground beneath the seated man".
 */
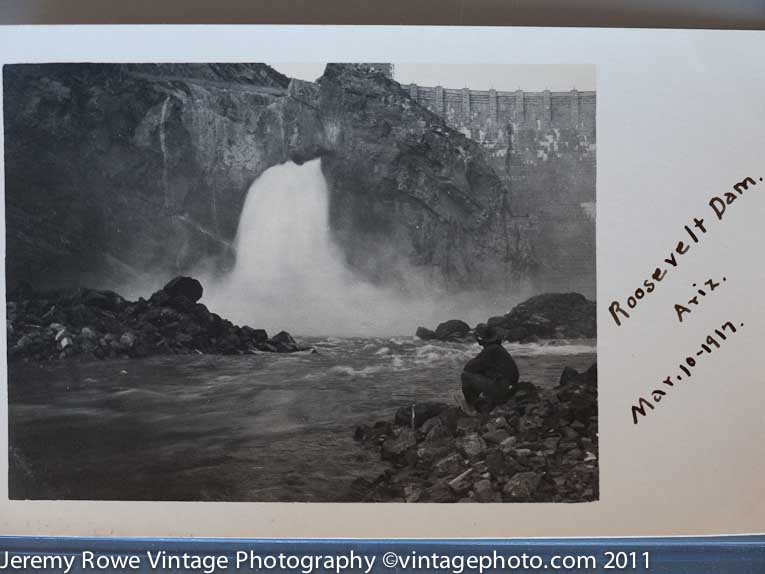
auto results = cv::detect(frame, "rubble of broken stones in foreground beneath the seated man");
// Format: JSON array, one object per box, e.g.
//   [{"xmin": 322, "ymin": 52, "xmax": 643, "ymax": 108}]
[{"xmin": 351, "ymin": 365, "xmax": 598, "ymax": 502}]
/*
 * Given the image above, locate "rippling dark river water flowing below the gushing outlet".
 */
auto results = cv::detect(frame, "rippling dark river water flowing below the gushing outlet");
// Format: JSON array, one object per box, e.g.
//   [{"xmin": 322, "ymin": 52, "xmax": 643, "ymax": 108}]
[{"xmin": 9, "ymin": 337, "xmax": 595, "ymax": 501}]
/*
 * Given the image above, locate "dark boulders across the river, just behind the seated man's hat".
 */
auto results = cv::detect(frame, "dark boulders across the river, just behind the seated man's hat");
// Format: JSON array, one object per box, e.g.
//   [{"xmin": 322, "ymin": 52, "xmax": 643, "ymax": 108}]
[{"xmin": 415, "ymin": 293, "xmax": 597, "ymax": 343}]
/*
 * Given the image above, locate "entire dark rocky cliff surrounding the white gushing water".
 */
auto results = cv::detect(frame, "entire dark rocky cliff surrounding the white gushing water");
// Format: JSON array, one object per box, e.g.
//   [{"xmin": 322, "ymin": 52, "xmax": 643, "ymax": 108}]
[{"xmin": 3, "ymin": 64, "xmax": 539, "ymax": 290}]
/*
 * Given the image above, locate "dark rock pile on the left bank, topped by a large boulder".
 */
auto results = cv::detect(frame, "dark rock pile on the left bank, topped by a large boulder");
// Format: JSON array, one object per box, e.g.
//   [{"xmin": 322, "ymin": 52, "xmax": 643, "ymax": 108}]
[{"xmin": 7, "ymin": 277, "xmax": 301, "ymax": 361}]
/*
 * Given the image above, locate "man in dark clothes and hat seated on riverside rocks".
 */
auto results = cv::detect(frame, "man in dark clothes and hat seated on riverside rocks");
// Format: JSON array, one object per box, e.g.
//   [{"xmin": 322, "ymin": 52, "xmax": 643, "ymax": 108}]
[{"xmin": 462, "ymin": 325, "xmax": 519, "ymax": 410}]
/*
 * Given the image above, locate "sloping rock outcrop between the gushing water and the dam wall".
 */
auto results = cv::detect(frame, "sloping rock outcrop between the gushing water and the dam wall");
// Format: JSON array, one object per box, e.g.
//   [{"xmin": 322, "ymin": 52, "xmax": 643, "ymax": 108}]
[{"xmin": 316, "ymin": 64, "xmax": 534, "ymax": 291}]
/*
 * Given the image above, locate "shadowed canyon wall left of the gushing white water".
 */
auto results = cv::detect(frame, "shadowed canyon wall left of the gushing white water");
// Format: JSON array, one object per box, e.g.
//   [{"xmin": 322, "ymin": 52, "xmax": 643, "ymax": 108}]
[{"xmin": 4, "ymin": 64, "xmax": 328, "ymax": 288}]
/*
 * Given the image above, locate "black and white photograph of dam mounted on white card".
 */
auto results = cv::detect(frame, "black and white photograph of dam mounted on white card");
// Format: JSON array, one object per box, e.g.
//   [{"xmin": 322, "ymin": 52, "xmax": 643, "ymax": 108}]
[{"xmin": 3, "ymin": 61, "xmax": 596, "ymax": 503}]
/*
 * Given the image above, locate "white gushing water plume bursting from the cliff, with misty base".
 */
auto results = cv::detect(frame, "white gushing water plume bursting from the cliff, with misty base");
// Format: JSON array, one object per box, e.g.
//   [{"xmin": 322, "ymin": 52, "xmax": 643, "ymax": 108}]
[{"xmin": 204, "ymin": 159, "xmax": 496, "ymax": 335}]
